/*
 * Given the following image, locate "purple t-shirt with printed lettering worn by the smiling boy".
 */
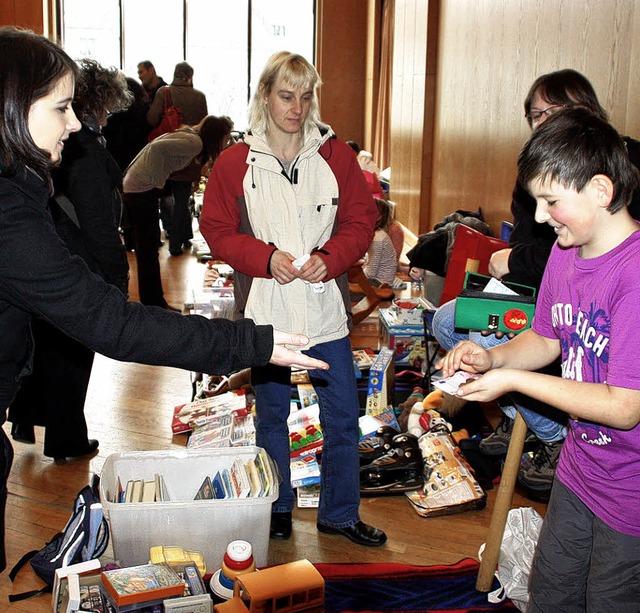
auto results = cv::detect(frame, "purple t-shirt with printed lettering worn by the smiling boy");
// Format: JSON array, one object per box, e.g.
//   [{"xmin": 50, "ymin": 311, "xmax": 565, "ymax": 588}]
[{"xmin": 533, "ymin": 230, "xmax": 640, "ymax": 537}]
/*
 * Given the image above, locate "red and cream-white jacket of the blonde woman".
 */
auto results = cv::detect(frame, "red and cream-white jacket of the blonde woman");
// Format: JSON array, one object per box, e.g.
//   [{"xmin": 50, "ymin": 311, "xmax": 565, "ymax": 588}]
[{"xmin": 200, "ymin": 126, "xmax": 378, "ymax": 346}]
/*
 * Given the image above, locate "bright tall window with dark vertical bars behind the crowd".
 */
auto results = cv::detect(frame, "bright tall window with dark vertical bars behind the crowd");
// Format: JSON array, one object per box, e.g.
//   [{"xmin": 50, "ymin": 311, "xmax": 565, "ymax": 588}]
[{"xmin": 60, "ymin": 0, "xmax": 315, "ymax": 130}]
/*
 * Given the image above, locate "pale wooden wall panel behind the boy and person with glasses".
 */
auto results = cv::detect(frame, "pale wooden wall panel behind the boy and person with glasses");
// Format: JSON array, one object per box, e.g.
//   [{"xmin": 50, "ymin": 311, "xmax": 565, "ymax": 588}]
[{"xmin": 430, "ymin": 0, "xmax": 640, "ymax": 231}]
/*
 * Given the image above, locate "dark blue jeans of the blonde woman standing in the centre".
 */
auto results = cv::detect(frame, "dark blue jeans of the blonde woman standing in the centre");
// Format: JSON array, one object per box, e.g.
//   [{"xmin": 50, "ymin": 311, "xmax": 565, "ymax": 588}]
[{"xmin": 251, "ymin": 337, "xmax": 360, "ymax": 528}]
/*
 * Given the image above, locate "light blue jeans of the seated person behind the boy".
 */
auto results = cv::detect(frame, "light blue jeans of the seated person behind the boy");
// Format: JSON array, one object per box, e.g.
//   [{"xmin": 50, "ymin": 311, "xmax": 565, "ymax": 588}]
[{"xmin": 432, "ymin": 300, "xmax": 567, "ymax": 443}]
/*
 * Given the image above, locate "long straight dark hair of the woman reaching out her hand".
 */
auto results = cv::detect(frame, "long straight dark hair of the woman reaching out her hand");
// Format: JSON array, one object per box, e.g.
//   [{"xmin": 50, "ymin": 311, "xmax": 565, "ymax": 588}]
[{"xmin": 0, "ymin": 26, "xmax": 79, "ymax": 176}]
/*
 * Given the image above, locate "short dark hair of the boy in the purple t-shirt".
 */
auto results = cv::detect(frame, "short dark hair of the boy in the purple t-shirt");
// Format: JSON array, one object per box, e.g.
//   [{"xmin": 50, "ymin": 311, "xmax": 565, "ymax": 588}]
[{"xmin": 518, "ymin": 108, "xmax": 640, "ymax": 213}]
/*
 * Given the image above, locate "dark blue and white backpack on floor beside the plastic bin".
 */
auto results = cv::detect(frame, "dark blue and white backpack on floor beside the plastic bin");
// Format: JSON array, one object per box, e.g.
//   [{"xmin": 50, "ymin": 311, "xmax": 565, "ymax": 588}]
[{"xmin": 9, "ymin": 475, "xmax": 109, "ymax": 602}]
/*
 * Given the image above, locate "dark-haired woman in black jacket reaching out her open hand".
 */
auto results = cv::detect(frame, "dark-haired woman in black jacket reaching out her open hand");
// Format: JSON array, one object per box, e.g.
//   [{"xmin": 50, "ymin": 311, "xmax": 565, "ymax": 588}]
[{"xmin": 0, "ymin": 27, "xmax": 328, "ymax": 572}]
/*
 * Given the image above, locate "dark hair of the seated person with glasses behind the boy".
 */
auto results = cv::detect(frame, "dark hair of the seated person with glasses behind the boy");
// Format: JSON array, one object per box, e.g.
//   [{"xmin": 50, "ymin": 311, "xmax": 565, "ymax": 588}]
[{"xmin": 524, "ymin": 68, "xmax": 609, "ymax": 126}]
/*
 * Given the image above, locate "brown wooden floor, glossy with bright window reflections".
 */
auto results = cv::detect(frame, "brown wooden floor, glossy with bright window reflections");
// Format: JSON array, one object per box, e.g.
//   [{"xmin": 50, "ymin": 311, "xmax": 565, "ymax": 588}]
[{"xmin": 0, "ymin": 232, "xmax": 545, "ymax": 613}]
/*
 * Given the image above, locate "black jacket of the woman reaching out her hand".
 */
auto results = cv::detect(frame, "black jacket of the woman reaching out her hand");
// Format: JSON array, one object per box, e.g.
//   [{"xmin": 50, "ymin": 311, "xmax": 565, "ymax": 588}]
[{"xmin": 0, "ymin": 160, "xmax": 273, "ymax": 422}]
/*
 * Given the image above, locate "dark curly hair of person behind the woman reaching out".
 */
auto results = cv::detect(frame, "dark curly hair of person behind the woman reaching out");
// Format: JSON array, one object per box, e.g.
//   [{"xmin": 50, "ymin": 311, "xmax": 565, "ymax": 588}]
[{"xmin": 73, "ymin": 58, "xmax": 133, "ymax": 120}]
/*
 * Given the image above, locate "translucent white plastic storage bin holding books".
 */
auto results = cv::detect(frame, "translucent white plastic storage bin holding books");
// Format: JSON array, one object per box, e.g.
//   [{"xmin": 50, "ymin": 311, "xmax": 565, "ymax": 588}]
[{"xmin": 100, "ymin": 446, "xmax": 278, "ymax": 572}]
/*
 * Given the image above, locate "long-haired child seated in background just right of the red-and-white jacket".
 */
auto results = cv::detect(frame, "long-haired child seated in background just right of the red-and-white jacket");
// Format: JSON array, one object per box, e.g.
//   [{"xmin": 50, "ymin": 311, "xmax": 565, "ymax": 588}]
[{"xmin": 364, "ymin": 198, "xmax": 404, "ymax": 289}]
